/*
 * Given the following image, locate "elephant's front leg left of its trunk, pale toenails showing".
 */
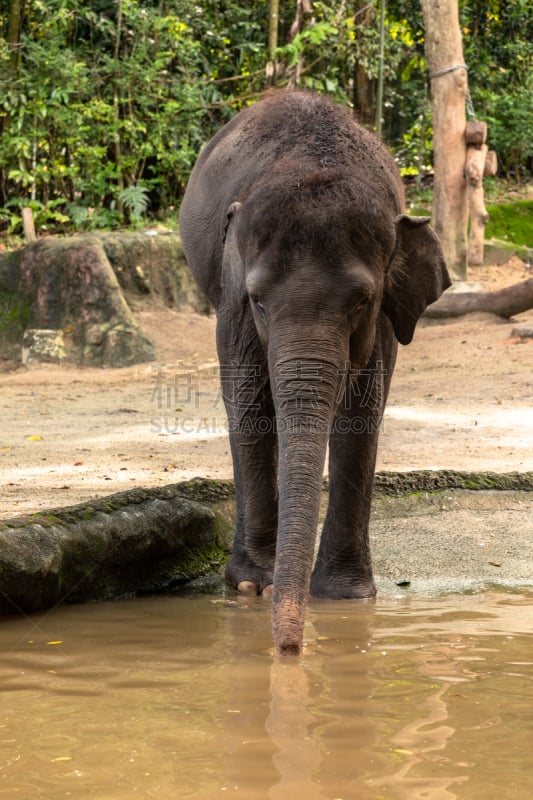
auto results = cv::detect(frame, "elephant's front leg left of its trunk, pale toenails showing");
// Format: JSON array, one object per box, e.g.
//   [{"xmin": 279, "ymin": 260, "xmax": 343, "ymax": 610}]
[{"xmin": 219, "ymin": 320, "xmax": 278, "ymax": 594}]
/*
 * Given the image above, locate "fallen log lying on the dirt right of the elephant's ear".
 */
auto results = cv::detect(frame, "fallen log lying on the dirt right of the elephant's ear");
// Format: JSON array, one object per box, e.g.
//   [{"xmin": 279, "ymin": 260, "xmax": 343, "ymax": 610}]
[{"xmin": 424, "ymin": 278, "xmax": 533, "ymax": 319}]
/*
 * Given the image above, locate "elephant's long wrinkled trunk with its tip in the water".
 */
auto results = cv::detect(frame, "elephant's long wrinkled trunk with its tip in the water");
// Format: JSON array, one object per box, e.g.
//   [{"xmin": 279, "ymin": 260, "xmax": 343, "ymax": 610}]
[{"xmin": 269, "ymin": 338, "xmax": 344, "ymax": 656}]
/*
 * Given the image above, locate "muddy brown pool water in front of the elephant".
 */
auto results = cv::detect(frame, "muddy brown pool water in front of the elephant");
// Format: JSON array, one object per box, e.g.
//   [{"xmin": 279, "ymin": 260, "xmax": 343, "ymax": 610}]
[{"xmin": 0, "ymin": 593, "xmax": 533, "ymax": 800}]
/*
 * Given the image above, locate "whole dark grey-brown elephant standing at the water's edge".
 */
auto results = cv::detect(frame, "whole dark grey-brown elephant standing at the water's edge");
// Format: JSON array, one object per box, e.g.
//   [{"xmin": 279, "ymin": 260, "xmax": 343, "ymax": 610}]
[{"xmin": 180, "ymin": 92, "xmax": 450, "ymax": 655}]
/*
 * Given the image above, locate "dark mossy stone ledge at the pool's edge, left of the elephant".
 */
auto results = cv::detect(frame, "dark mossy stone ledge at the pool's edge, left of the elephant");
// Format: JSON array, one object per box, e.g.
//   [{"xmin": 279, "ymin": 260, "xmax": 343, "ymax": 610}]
[{"xmin": 0, "ymin": 485, "xmax": 231, "ymax": 615}]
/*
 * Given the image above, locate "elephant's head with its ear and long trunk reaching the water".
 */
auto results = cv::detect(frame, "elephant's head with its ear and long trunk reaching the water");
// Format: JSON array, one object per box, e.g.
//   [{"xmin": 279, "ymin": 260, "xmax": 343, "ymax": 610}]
[{"xmin": 223, "ymin": 162, "xmax": 450, "ymax": 655}]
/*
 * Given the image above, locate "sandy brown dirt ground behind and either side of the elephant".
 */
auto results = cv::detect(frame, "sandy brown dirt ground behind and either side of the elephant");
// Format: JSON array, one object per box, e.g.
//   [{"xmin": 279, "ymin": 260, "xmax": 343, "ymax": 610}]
[{"xmin": 0, "ymin": 259, "xmax": 533, "ymax": 518}]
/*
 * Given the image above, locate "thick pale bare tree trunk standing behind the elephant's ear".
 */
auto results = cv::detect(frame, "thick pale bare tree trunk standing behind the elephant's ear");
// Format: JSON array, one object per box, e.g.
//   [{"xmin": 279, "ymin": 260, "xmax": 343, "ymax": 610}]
[{"xmin": 422, "ymin": 0, "xmax": 468, "ymax": 280}]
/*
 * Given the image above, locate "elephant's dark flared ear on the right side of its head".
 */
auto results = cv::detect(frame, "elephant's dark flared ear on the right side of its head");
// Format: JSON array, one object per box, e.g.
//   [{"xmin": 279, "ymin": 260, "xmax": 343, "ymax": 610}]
[{"xmin": 382, "ymin": 214, "xmax": 451, "ymax": 344}]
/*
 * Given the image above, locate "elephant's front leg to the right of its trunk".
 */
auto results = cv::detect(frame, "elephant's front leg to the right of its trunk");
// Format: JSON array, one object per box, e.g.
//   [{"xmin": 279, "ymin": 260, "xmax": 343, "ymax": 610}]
[{"xmin": 311, "ymin": 328, "xmax": 396, "ymax": 599}]
